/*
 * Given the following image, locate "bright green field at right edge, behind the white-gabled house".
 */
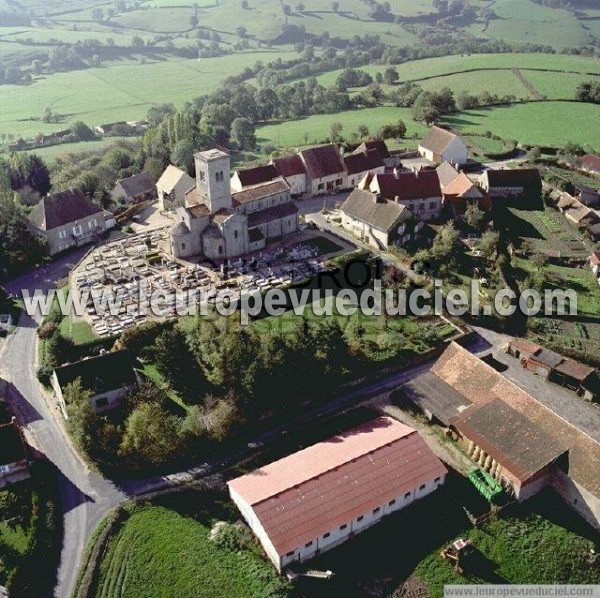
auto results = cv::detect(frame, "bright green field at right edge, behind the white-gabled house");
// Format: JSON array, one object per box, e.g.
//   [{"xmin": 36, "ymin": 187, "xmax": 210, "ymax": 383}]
[{"xmin": 443, "ymin": 102, "xmax": 600, "ymax": 147}]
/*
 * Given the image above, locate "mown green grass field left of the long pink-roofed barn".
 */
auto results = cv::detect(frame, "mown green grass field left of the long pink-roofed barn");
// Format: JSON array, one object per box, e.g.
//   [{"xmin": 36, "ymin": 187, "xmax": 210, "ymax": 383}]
[{"xmin": 95, "ymin": 491, "xmax": 289, "ymax": 598}]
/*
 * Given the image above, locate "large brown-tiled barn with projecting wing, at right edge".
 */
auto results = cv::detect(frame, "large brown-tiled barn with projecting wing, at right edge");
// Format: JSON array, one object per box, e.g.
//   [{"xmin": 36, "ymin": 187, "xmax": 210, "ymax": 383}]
[{"xmin": 403, "ymin": 343, "xmax": 600, "ymax": 529}]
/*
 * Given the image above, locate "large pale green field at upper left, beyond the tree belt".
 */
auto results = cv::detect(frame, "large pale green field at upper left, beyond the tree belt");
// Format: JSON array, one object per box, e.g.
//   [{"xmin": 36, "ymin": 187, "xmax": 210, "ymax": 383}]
[{"xmin": 0, "ymin": 50, "xmax": 295, "ymax": 137}]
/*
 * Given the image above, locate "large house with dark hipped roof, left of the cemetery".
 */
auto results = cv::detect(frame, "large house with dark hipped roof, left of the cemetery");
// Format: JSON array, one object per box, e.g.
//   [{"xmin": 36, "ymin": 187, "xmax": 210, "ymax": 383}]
[{"xmin": 28, "ymin": 189, "xmax": 106, "ymax": 255}]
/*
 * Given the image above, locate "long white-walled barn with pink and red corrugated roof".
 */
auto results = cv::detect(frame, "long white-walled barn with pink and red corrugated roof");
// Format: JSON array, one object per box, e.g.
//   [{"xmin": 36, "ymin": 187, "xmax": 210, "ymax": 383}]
[{"xmin": 228, "ymin": 417, "xmax": 447, "ymax": 572}]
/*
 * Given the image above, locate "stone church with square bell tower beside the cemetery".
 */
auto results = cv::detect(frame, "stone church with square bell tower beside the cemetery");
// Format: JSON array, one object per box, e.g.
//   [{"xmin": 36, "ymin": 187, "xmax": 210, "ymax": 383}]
[{"xmin": 170, "ymin": 149, "xmax": 298, "ymax": 260}]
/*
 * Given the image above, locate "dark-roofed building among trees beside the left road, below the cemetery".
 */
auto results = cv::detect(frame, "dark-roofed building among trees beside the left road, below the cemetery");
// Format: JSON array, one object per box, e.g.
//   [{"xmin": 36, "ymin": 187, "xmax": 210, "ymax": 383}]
[{"xmin": 50, "ymin": 350, "xmax": 138, "ymax": 417}]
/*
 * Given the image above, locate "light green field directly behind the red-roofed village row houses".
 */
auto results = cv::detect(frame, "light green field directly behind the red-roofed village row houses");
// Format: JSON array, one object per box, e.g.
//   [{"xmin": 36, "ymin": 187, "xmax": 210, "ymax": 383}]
[{"xmin": 257, "ymin": 107, "xmax": 427, "ymax": 147}]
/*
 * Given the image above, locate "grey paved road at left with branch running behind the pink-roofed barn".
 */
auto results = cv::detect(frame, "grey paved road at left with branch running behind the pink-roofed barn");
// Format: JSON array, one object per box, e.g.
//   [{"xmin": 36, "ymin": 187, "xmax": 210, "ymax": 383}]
[{"xmin": 0, "ymin": 247, "xmax": 485, "ymax": 598}]
